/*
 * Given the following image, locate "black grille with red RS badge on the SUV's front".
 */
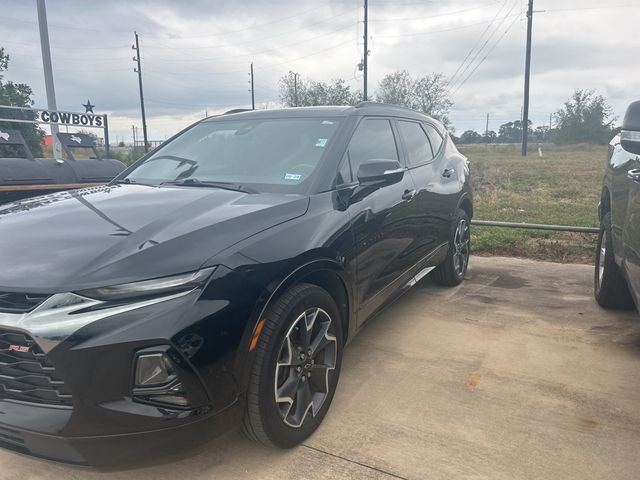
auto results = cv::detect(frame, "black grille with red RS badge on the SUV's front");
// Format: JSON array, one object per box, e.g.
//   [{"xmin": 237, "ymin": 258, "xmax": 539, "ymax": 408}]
[{"xmin": 0, "ymin": 330, "xmax": 73, "ymax": 407}]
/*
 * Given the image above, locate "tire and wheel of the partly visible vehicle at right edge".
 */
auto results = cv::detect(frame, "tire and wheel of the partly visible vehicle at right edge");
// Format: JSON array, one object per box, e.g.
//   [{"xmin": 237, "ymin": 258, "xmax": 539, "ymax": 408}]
[{"xmin": 593, "ymin": 213, "xmax": 634, "ymax": 310}]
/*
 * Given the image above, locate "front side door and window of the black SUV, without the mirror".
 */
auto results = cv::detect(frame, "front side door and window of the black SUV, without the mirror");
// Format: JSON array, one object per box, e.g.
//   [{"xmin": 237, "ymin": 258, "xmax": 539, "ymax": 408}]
[{"xmin": 340, "ymin": 117, "xmax": 419, "ymax": 318}]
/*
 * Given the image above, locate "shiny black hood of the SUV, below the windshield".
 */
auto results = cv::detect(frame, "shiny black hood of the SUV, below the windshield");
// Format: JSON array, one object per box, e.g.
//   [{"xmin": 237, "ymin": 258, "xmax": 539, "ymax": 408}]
[{"xmin": 0, "ymin": 185, "xmax": 309, "ymax": 293}]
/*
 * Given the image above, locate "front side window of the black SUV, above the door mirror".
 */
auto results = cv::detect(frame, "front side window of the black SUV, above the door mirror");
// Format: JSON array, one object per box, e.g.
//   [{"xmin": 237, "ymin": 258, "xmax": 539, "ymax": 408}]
[{"xmin": 338, "ymin": 118, "xmax": 399, "ymax": 184}]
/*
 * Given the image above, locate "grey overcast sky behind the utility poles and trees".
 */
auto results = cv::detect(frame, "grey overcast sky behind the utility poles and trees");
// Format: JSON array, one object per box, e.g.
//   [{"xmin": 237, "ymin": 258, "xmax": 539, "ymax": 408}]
[{"xmin": 0, "ymin": 0, "xmax": 640, "ymax": 142}]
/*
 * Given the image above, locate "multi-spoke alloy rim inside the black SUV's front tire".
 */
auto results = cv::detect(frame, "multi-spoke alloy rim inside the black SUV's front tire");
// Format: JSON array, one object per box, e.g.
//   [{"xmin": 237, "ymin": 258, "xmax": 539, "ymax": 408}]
[{"xmin": 275, "ymin": 308, "xmax": 338, "ymax": 428}]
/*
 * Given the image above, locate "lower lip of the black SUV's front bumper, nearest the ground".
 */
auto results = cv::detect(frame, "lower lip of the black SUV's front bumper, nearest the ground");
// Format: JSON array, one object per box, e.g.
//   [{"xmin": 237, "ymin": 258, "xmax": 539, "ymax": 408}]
[{"xmin": 0, "ymin": 394, "xmax": 244, "ymax": 470}]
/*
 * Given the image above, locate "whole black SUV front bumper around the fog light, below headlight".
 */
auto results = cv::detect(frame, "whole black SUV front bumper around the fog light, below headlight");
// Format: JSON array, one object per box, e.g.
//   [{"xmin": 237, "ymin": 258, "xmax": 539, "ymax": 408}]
[{"xmin": 0, "ymin": 267, "xmax": 262, "ymax": 469}]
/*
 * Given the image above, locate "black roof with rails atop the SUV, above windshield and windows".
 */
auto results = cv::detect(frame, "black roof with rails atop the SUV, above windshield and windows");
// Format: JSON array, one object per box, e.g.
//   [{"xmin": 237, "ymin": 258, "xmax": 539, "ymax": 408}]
[{"xmin": 204, "ymin": 102, "xmax": 440, "ymax": 123}]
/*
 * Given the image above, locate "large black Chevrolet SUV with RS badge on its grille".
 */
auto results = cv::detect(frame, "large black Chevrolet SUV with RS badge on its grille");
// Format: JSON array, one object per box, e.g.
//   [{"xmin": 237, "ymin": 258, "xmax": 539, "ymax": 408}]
[{"xmin": 0, "ymin": 103, "xmax": 473, "ymax": 466}]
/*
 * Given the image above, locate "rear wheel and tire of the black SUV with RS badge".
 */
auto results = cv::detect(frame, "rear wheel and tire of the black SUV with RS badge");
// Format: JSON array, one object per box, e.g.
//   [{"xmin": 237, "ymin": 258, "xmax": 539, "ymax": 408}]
[{"xmin": 431, "ymin": 208, "xmax": 471, "ymax": 287}]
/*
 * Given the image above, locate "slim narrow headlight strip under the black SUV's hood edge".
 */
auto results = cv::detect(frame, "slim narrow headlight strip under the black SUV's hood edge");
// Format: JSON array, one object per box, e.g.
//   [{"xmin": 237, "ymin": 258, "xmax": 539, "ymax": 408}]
[{"xmin": 75, "ymin": 267, "xmax": 215, "ymax": 301}]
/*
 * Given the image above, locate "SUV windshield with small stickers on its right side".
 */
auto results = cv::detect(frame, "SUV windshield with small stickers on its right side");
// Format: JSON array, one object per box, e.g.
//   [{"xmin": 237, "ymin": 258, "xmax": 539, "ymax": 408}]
[{"xmin": 119, "ymin": 118, "xmax": 339, "ymax": 193}]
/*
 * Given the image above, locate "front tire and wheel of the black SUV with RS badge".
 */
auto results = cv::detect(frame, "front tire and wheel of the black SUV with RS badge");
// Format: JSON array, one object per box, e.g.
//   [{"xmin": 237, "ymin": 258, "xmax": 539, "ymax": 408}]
[{"xmin": 242, "ymin": 283, "xmax": 343, "ymax": 448}]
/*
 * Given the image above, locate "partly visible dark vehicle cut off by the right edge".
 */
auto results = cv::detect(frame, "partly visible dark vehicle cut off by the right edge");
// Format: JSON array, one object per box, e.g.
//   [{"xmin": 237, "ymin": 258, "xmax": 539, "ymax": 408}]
[{"xmin": 594, "ymin": 101, "xmax": 640, "ymax": 308}]
